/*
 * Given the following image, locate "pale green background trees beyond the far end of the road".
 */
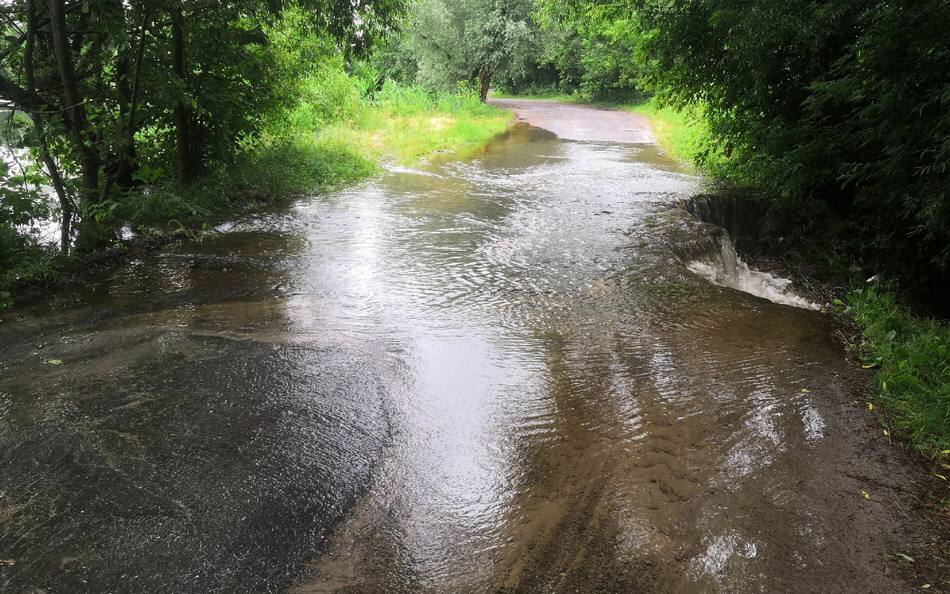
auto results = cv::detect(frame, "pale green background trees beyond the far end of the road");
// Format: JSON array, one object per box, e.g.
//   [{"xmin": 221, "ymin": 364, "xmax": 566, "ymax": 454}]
[{"xmin": 373, "ymin": 0, "xmax": 643, "ymax": 99}]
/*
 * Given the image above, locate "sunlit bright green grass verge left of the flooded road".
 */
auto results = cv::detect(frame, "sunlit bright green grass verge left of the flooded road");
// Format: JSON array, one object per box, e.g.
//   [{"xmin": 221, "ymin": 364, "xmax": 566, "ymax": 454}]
[{"xmin": 189, "ymin": 77, "xmax": 513, "ymax": 210}]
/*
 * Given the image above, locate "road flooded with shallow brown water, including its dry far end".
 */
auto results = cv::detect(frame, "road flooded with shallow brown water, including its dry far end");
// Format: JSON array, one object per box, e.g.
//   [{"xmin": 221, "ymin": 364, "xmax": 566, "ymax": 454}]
[{"xmin": 0, "ymin": 102, "xmax": 934, "ymax": 593}]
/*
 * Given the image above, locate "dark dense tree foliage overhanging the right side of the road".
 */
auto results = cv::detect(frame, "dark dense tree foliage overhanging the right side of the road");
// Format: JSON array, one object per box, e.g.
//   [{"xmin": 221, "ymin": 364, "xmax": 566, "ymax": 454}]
[{"xmin": 631, "ymin": 0, "xmax": 950, "ymax": 294}]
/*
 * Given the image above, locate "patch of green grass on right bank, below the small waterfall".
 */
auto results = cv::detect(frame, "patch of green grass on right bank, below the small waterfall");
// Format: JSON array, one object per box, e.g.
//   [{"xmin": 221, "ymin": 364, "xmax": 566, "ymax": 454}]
[{"xmin": 847, "ymin": 285, "xmax": 950, "ymax": 458}]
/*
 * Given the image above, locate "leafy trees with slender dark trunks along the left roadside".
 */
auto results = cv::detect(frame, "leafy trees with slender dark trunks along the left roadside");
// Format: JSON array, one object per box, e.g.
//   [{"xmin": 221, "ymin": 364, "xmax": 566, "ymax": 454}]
[{"xmin": 0, "ymin": 0, "xmax": 402, "ymax": 254}]
